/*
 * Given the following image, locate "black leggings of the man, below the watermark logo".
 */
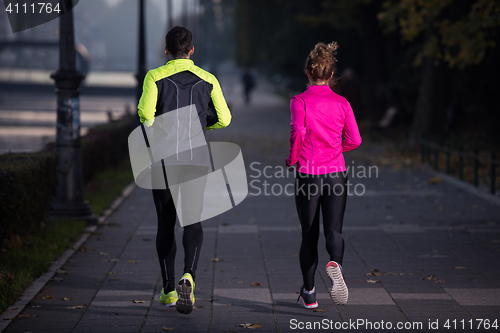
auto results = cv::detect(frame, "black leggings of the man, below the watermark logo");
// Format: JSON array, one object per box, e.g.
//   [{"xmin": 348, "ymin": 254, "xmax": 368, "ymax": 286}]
[{"xmin": 153, "ymin": 189, "xmax": 203, "ymax": 293}]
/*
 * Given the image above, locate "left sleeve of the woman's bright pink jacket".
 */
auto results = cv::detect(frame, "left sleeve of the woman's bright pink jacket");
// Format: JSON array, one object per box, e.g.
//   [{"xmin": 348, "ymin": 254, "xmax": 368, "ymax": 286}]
[{"xmin": 286, "ymin": 96, "xmax": 306, "ymax": 165}]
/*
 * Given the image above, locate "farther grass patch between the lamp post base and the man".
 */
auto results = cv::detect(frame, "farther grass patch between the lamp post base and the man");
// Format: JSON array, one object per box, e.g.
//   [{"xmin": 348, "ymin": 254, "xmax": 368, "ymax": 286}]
[{"xmin": 84, "ymin": 160, "xmax": 134, "ymax": 216}]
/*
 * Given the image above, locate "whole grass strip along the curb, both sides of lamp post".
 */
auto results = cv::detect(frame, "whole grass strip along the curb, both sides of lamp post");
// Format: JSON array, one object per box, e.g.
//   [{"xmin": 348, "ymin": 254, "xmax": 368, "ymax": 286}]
[{"xmin": 0, "ymin": 160, "xmax": 134, "ymax": 313}]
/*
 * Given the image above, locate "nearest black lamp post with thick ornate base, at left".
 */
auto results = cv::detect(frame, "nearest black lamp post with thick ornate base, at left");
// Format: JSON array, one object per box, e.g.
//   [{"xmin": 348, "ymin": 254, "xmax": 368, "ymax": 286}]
[{"xmin": 50, "ymin": 10, "xmax": 96, "ymax": 221}]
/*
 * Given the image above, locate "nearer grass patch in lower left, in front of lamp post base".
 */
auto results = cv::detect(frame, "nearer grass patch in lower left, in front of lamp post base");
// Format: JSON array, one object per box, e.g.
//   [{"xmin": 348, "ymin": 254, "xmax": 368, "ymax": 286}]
[{"xmin": 0, "ymin": 221, "xmax": 87, "ymax": 313}]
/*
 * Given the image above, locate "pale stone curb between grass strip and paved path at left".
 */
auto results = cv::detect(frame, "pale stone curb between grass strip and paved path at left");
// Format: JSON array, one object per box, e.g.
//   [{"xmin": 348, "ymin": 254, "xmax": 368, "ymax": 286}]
[{"xmin": 0, "ymin": 183, "xmax": 136, "ymax": 333}]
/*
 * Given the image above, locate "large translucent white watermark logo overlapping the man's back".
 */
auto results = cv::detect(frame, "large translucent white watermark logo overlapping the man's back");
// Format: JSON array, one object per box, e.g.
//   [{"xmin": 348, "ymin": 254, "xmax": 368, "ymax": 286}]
[{"xmin": 128, "ymin": 104, "xmax": 248, "ymax": 227}]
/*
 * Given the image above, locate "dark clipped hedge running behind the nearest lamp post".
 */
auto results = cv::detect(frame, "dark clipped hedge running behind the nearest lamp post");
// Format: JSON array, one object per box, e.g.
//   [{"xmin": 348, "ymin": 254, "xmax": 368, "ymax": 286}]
[{"xmin": 0, "ymin": 116, "xmax": 138, "ymax": 245}]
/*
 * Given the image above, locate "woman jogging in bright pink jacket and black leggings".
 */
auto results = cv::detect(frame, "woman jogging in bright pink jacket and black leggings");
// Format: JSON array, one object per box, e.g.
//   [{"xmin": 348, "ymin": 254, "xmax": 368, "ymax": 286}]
[{"xmin": 286, "ymin": 42, "xmax": 361, "ymax": 308}]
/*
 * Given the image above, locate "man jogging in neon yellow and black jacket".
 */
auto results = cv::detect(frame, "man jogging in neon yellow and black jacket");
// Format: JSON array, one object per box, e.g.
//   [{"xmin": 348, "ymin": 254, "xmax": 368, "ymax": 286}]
[{"xmin": 138, "ymin": 26, "xmax": 231, "ymax": 314}]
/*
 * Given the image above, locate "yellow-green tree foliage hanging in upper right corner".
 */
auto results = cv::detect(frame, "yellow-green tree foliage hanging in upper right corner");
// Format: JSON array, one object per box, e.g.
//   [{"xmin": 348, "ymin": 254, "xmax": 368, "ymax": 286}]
[{"xmin": 378, "ymin": 0, "xmax": 500, "ymax": 68}]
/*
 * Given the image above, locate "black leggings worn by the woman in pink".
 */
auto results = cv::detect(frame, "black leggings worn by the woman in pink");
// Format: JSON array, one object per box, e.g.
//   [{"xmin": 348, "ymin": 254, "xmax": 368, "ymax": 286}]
[{"xmin": 295, "ymin": 172, "xmax": 347, "ymax": 290}]
